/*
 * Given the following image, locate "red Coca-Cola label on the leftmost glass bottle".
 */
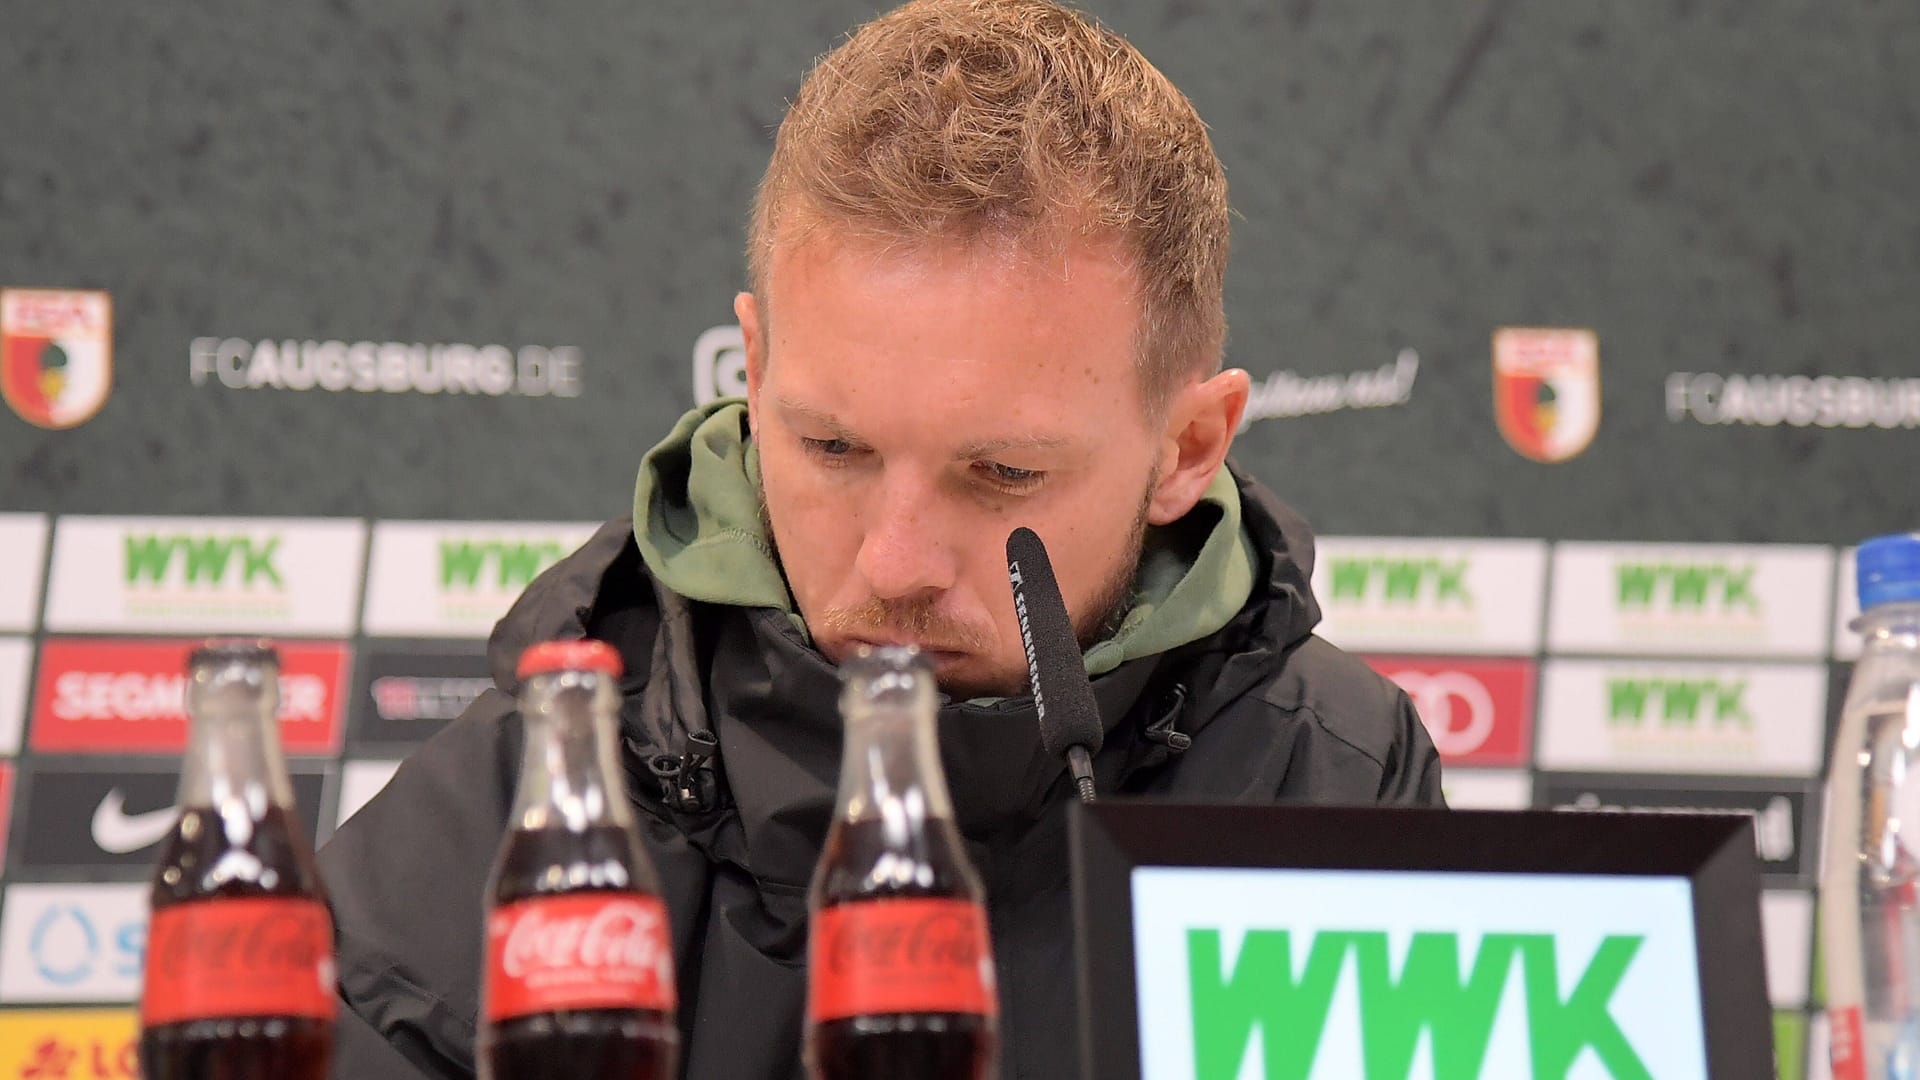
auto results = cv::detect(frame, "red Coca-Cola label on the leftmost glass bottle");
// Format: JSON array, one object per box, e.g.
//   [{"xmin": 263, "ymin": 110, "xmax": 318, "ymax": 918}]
[{"xmin": 140, "ymin": 897, "xmax": 336, "ymax": 1026}]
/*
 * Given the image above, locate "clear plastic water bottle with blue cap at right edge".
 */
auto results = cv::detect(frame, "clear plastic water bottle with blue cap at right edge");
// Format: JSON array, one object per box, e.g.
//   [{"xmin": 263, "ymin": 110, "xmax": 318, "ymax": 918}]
[{"xmin": 1820, "ymin": 532, "xmax": 1920, "ymax": 1080}]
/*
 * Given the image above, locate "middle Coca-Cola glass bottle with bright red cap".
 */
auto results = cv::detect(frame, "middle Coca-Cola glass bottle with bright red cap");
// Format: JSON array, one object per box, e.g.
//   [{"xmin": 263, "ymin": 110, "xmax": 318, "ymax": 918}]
[{"xmin": 476, "ymin": 642, "xmax": 680, "ymax": 1080}]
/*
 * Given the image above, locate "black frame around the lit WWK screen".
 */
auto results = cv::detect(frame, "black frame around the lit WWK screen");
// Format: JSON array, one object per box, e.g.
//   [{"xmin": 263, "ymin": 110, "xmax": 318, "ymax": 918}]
[{"xmin": 1068, "ymin": 799, "xmax": 1774, "ymax": 1080}]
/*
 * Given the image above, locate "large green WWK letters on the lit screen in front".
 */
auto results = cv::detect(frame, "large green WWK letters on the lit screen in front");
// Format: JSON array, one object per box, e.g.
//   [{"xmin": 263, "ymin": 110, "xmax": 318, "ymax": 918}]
[{"xmin": 1187, "ymin": 928, "xmax": 1653, "ymax": 1080}]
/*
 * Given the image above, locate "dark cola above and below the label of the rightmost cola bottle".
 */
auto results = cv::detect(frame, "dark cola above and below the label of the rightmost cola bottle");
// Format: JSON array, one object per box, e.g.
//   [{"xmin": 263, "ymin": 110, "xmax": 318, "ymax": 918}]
[{"xmin": 806, "ymin": 821, "xmax": 1000, "ymax": 1080}]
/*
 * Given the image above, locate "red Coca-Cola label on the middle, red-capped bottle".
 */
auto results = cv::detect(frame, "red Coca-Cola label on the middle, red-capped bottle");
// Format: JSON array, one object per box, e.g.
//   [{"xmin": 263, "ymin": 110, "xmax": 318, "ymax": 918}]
[{"xmin": 486, "ymin": 892, "xmax": 676, "ymax": 1022}]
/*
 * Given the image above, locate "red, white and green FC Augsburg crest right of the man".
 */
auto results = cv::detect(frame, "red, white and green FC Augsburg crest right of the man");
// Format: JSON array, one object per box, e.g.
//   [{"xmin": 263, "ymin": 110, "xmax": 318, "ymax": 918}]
[{"xmin": 1494, "ymin": 327, "xmax": 1599, "ymax": 465}]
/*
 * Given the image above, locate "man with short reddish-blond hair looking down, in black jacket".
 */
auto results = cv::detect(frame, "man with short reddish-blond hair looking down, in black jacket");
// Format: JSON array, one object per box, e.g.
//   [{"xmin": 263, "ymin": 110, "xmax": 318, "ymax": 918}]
[{"xmin": 321, "ymin": 0, "xmax": 1440, "ymax": 1080}]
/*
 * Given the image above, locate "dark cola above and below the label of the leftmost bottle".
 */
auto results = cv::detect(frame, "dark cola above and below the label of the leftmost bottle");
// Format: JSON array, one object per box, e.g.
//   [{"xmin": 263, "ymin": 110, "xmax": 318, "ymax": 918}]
[{"xmin": 140, "ymin": 805, "xmax": 334, "ymax": 1080}]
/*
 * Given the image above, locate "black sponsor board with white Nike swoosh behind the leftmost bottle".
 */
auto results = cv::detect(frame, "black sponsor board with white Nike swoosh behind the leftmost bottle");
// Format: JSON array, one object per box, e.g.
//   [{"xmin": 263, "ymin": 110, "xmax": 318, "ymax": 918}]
[{"xmin": 13, "ymin": 761, "xmax": 332, "ymax": 876}]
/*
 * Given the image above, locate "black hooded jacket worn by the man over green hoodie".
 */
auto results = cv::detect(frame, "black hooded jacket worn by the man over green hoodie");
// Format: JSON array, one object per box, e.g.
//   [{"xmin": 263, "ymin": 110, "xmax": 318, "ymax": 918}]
[{"xmin": 321, "ymin": 470, "xmax": 1440, "ymax": 1080}]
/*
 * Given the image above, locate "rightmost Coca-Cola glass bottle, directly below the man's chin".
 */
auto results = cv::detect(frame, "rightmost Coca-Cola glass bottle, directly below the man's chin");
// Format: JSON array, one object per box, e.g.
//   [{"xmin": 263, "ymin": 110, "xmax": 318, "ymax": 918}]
[{"xmin": 804, "ymin": 646, "xmax": 1000, "ymax": 1080}]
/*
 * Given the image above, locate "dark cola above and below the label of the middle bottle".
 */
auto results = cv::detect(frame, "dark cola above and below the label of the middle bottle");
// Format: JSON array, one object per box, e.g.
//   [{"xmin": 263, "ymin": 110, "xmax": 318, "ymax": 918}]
[{"xmin": 480, "ymin": 824, "xmax": 680, "ymax": 1080}]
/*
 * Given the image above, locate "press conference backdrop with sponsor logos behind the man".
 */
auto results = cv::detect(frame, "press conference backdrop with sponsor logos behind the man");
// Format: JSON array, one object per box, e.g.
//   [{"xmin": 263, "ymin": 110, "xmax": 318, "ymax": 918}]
[{"xmin": 0, "ymin": 0, "xmax": 1920, "ymax": 1078}]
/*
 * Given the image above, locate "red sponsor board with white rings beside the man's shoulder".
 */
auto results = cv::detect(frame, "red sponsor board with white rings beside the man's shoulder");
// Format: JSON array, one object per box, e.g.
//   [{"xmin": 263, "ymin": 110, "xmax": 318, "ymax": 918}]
[{"xmin": 1365, "ymin": 657, "xmax": 1534, "ymax": 767}]
